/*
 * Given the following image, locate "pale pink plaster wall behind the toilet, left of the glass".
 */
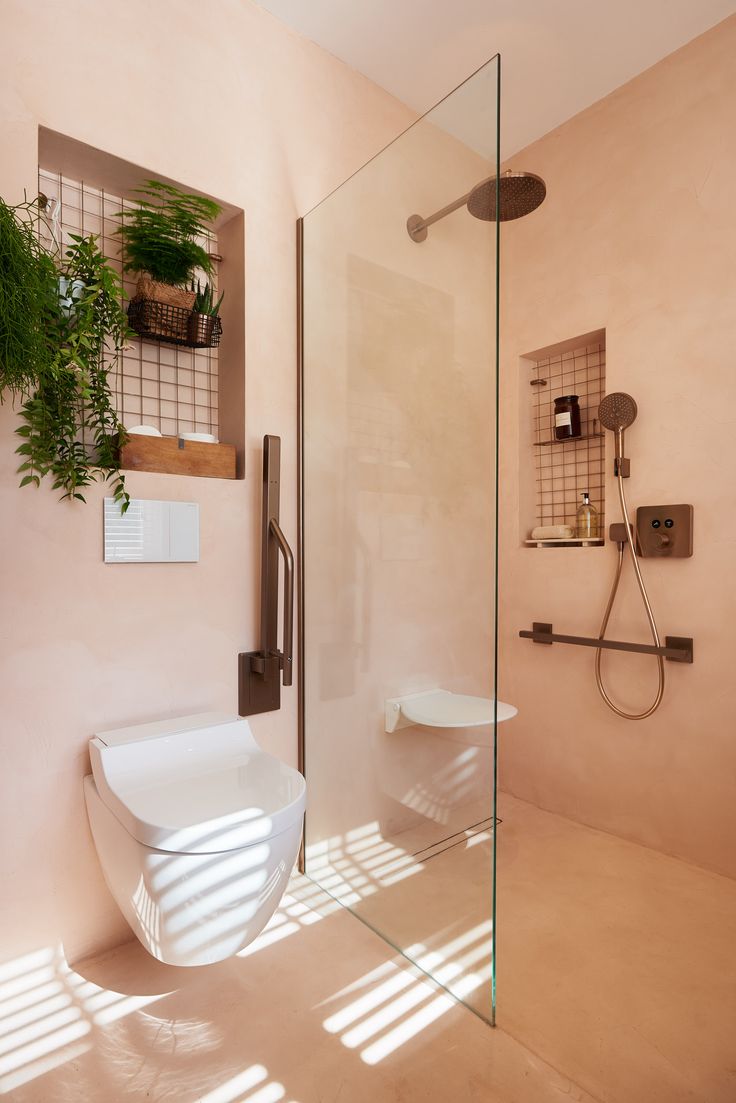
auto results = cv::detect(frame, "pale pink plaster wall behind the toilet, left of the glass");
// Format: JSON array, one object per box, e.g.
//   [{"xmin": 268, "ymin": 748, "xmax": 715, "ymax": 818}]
[{"xmin": 0, "ymin": 0, "xmax": 410, "ymax": 959}]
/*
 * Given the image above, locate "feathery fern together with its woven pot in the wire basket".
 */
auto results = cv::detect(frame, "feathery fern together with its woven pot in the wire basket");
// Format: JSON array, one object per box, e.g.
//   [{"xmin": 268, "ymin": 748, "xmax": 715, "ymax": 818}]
[{"xmin": 117, "ymin": 180, "xmax": 222, "ymax": 342}]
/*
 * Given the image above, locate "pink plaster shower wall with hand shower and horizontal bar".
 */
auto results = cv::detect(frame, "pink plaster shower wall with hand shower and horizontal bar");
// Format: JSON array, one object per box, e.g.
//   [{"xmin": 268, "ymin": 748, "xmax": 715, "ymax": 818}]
[{"xmin": 500, "ymin": 18, "xmax": 736, "ymax": 876}]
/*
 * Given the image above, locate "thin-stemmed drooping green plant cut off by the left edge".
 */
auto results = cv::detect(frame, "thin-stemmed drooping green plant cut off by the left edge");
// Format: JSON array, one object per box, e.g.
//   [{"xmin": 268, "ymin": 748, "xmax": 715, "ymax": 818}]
[{"xmin": 0, "ymin": 199, "xmax": 57, "ymax": 401}]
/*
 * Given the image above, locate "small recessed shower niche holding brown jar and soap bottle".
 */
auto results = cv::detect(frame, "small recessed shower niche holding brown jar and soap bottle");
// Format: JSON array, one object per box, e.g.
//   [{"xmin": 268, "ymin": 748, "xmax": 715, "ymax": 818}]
[{"xmin": 520, "ymin": 330, "xmax": 606, "ymax": 547}]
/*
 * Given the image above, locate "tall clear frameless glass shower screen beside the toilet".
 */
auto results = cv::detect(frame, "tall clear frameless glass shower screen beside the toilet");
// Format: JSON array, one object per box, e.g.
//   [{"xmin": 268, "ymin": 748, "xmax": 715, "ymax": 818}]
[{"xmin": 300, "ymin": 58, "xmax": 499, "ymax": 1021}]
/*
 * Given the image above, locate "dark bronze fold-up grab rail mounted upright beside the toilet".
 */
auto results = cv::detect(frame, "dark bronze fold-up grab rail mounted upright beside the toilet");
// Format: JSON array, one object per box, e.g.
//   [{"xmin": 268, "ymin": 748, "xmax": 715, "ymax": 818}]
[{"xmin": 237, "ymin": 435, "xmax": 294, "ymax": 716}]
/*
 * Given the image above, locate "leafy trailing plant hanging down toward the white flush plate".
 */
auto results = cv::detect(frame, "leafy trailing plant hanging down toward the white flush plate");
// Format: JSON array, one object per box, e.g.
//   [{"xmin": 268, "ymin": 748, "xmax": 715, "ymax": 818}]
[{"xmin": 17, "ymin": 234, "xmax": 131, "ymax": 512}]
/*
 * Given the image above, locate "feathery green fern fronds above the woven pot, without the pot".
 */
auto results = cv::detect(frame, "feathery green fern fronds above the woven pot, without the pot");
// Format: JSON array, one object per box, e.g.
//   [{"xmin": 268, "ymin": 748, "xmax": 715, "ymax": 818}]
[{"xmin": 116, "ymin": 180, "xmax": 222, "ymax": 287}]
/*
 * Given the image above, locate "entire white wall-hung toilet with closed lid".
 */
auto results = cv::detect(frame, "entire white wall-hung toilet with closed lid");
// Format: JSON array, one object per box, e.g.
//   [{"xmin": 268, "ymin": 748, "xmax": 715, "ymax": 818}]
[{"xmin": 84, "ymin": 714, "xmax": 306, "ymax": 965}]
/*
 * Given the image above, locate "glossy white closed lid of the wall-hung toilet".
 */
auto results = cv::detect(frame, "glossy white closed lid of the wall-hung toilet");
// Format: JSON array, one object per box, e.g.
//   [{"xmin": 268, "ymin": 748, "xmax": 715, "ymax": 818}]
[{"xmin": 90, "ymin": 715, "xmax": 306, "ymax": 854}]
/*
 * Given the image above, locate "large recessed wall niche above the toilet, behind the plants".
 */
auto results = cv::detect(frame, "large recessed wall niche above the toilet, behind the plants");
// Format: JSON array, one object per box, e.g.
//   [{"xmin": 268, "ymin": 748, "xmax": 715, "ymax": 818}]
[{"xmin": 39, "ymin": 127, "xmax": 245, "ymax": 479}]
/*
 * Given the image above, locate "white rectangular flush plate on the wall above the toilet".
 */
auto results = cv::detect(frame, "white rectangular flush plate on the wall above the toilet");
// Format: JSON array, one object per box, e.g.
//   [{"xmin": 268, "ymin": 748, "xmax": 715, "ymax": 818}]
[{"xmin": 104, "ymin": 497, "xmax": 200, "ymax": 563}]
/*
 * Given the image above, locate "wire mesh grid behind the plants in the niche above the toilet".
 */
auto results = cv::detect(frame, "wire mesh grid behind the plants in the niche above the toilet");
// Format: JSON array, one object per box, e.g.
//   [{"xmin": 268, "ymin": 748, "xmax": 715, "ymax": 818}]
[{"xmin": 39, "ymin": 169, "xmax": 217, "ymax": 437}]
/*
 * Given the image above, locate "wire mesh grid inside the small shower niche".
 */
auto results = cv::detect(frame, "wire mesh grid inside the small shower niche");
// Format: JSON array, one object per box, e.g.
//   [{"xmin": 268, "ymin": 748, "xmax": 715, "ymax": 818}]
[{"xmin": 531, "ymin": 342, "xmax": 606, "ymax": 533}]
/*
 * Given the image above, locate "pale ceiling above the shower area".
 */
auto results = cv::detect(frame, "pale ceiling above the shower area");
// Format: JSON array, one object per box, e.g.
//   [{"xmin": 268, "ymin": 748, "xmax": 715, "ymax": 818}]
[{"xmin": 258, "ymin": 0, "xmax": 736, "ymax": 157}]
